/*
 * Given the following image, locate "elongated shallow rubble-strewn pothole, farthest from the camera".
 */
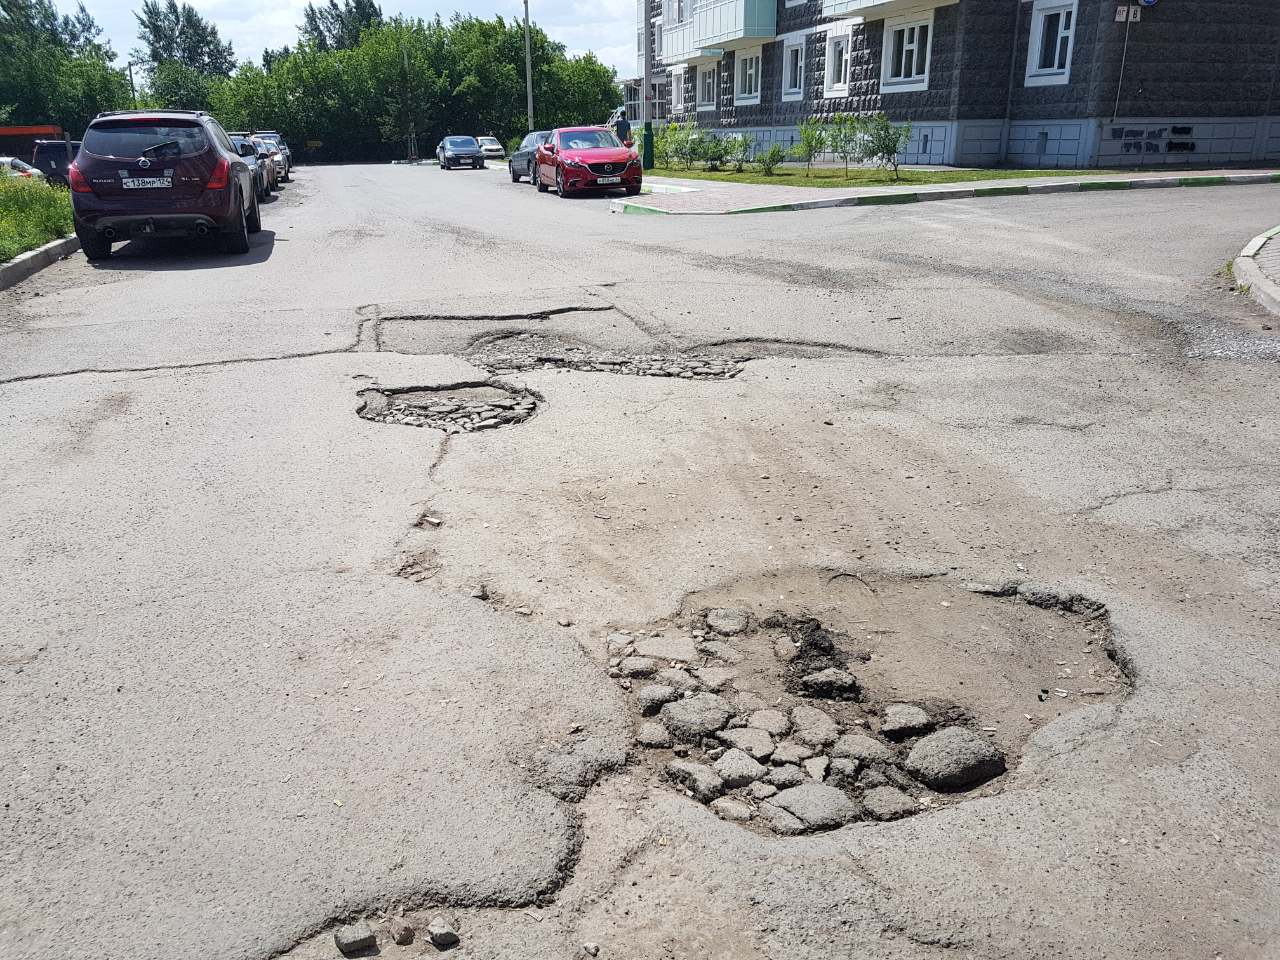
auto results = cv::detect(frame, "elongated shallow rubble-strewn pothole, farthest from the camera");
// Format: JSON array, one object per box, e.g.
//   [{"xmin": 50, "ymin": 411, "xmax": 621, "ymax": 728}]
[{"xmin": 466, "ymin": 333, "xmax": 750, "ymax": 380}]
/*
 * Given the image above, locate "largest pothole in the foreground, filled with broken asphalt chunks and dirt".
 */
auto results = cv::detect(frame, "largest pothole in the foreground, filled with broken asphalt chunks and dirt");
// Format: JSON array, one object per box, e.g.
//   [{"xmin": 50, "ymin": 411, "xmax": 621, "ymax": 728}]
[{"xmin": 604, "ymin": 577, "xmax": 1130, "ymax": 835}]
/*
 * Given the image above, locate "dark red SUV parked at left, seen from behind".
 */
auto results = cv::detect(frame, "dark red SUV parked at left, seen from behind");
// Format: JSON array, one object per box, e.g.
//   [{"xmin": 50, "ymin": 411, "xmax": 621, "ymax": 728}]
[{"xmin": 68, "ymin": 110, "xmax": 262, "ymax": 260}]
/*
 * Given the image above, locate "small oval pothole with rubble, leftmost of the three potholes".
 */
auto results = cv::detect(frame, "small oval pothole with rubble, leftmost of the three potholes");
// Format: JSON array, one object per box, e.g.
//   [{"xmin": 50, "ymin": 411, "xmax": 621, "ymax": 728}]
[{"xmin": 356, "ymin": 381, "xmax": 540, "ymax": 434}]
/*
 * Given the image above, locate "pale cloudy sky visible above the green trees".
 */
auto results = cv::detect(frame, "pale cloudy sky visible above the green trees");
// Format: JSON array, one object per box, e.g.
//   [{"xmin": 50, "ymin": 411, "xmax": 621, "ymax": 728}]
[{"xmin": 55, "ymin": 0, "xmax": 636, "ymax": 78}]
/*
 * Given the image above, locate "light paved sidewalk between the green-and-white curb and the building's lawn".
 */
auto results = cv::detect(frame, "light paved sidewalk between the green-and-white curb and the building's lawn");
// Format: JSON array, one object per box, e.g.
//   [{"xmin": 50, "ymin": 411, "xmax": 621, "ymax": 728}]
[{"xmin": 612, "ymin": 169, "xmax": 1280, "ymax": 215}]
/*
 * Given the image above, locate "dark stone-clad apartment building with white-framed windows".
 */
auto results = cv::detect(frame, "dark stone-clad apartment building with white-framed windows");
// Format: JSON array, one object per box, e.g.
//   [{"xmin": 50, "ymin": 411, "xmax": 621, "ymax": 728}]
[{"xmin": 637, "ymin": 0, "xmax": 1280, "ymax": 166}]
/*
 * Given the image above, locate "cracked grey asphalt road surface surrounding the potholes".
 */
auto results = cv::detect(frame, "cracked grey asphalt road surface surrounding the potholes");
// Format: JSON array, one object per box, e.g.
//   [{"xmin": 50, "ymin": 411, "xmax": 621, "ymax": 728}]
[{"xmin": 0, "ymin": 166, "xmax": 1280, "ymax": 960}]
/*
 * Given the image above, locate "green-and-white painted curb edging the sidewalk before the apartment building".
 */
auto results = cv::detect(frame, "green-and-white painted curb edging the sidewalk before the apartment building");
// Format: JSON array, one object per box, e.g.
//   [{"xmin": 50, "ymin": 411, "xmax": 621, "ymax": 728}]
[{"xmin": 609, "ymin": 173, "xmax": 1280, "ymax": 216}]
